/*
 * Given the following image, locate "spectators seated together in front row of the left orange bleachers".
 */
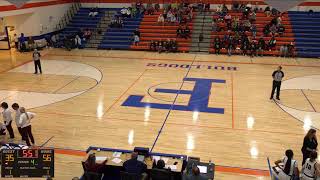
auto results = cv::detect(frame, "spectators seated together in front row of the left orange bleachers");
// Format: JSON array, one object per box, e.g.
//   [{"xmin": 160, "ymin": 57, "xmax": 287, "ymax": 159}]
[{"xmin": 149, "ymin": 39, "xmax": 178, "ymax": 53}]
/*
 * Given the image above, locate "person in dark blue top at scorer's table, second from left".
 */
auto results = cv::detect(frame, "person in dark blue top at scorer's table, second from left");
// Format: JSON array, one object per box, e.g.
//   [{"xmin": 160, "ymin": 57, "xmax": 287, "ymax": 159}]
[{"xmin": 123, "ymin": 152, "xmax": 147, "ymax": 179}]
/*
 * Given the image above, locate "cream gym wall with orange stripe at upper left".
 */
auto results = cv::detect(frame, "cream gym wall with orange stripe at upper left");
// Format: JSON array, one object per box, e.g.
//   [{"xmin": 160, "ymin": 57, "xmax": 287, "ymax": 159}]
[{"xmin": 0, "ymin": 0, "xmax": 72, "ymax": 36}]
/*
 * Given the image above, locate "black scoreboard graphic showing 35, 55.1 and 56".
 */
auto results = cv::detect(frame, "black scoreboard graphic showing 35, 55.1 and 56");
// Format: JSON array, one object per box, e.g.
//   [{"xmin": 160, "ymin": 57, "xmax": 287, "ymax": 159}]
[{"xmin": 1, "ymin": 149, "xmax": 54, "ymax": 178}]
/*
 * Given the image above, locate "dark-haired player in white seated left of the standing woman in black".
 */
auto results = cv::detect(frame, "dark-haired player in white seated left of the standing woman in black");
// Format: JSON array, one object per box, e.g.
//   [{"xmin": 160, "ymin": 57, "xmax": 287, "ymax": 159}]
[{"xmin": 272, "ymin": 149, "xmax": 299, "ymax": 180}]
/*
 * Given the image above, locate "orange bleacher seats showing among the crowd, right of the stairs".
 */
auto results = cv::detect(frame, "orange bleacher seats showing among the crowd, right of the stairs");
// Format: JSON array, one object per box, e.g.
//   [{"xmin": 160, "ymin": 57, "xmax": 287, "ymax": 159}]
[{"xmin": 210, "ymin": 12, "xmax": 294, "ymax": 55}]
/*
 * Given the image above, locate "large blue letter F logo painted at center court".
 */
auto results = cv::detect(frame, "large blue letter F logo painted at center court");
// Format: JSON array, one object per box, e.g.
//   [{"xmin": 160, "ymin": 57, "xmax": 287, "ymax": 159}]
[{"xmin": 122, "ymin": 78, "xmax": 226, "ymax": 114}]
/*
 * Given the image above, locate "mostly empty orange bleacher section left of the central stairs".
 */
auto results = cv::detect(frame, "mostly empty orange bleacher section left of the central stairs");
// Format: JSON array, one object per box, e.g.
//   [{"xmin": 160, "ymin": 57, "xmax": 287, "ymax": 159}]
[{"xmin": 131, "ymin": 10, "xmax": 192, "ymax": 52}]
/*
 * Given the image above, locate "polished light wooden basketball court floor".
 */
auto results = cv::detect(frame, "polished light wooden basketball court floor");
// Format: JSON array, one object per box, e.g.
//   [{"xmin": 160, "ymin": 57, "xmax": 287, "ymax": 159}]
[{"xmin": 0, "ymin": 49, "xmax": 320, "ymax": 180}]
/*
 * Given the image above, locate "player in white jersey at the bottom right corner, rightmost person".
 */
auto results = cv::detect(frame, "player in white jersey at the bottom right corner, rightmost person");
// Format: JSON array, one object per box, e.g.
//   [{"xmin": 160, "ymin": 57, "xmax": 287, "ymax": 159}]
[{"xmin": 301, "ymin": 151, "xmax": 320, "ymax": 180}]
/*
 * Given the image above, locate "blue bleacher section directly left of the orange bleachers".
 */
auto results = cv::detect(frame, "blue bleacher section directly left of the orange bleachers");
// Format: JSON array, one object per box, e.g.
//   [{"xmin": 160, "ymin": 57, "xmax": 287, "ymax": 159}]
[{"xmin": 98, "ymin": 11, "xmax": 143, "ymax": 50}]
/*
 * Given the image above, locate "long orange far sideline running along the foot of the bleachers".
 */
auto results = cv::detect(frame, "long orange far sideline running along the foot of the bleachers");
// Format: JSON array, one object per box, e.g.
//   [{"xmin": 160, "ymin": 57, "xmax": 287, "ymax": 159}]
[{"xmin": 48, "ymin": 54, "xmax": 320, "ymax": 68}]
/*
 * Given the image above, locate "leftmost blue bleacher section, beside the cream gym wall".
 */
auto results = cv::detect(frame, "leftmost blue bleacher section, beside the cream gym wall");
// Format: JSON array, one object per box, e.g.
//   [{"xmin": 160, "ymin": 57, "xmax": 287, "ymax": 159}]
[{"xmin": 59, "ymin": 8, "xmax": 104, "ymax": 46}]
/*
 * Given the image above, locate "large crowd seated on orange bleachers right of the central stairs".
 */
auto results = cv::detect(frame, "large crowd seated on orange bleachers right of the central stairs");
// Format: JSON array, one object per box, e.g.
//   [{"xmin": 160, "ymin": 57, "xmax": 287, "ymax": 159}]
[{"xmin": 212, "ymin": 2, "xmax": 294, "ymax": 57}]
